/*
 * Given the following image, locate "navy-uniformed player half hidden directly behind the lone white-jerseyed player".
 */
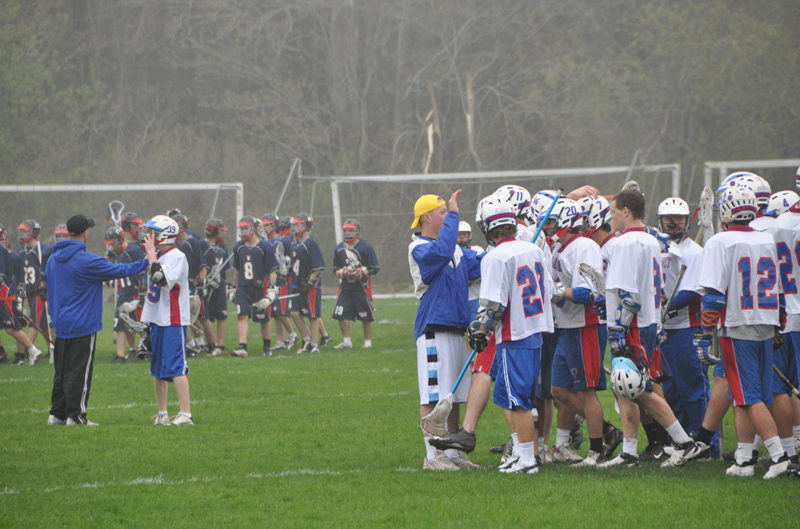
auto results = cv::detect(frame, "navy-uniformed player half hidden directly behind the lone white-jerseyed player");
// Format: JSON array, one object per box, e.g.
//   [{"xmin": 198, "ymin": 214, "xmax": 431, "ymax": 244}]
[{"xmin": 171, "ymin": 212, "xmax": 208, "ymax": 356}]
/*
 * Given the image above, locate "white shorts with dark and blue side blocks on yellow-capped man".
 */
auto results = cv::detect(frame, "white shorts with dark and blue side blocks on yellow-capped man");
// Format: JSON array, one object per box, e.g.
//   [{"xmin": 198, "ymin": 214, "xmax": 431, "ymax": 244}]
[{"xmin": 417, "ymin": 332, "xmax": 471, "ymax": 405}]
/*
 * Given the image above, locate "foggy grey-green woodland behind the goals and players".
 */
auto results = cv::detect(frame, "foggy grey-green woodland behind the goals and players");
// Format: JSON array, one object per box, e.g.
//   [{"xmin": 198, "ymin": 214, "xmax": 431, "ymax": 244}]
[{"xmin": 0, "ymin": 0, "xmax": 800, "ymax": 292}]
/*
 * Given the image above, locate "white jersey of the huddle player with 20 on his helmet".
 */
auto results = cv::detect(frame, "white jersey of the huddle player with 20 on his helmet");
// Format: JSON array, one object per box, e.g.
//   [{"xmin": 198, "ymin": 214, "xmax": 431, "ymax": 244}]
[{"xmin": 553, "ymin": 235, "xmax": 603, "ymax": 329}]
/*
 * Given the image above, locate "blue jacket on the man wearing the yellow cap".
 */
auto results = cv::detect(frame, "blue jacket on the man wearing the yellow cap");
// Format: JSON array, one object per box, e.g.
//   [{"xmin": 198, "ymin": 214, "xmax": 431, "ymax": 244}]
[{"xmin": 408, "ymin": 211, "xmax": 481, "ymax": 339}]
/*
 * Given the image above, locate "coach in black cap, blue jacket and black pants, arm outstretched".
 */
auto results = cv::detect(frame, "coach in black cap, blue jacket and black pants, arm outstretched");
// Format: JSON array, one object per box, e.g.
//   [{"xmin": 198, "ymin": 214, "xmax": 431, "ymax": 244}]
[{"xmin": 45, "ymin": 215, "xmax": 157, "ymax": 426}]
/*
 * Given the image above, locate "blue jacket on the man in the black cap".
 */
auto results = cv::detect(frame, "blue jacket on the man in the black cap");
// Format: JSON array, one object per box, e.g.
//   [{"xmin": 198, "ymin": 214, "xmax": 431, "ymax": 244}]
[{"xmin": 45, "ymin": 240, "xmax": 147, "ymax": 339}]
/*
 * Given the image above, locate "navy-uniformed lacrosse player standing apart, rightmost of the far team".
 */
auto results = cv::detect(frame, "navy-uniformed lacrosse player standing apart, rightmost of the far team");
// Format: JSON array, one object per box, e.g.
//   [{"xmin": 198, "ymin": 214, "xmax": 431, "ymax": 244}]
[{"xmin": 333, "ymin": 219, "xmax": 380, "ymax": 349}]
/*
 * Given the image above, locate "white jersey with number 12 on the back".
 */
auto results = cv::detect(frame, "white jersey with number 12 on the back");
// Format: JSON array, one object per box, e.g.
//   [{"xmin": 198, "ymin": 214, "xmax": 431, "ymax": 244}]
[{"xmin": 700, "ymin": 226, "xmax": 781, "ymax": 328}]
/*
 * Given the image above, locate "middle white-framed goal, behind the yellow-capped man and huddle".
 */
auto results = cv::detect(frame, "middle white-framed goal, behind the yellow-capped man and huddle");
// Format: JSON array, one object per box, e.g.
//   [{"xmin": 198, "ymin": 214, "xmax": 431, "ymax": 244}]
[{"xmin": 301, "ymin": 164, "xmax": 681, "ymax": 294}]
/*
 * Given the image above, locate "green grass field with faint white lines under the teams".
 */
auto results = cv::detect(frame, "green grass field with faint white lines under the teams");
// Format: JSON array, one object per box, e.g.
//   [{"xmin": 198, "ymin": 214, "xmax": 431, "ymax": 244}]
[{"xmin": 0, "ymin": 300, "xmax": 800, "ymax": 528}]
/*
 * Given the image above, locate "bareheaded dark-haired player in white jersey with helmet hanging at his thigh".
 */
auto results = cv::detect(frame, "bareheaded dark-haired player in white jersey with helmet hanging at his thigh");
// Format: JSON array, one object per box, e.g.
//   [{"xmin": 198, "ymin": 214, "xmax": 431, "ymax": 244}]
[{"xmin": 598, "ymin": 189, "xmax": 699, "ymax": 468}]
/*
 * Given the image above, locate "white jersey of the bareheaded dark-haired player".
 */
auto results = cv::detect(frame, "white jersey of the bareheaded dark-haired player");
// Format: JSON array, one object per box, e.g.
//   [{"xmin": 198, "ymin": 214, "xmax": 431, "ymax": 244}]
[{"xmin": 606, "ymin": 228, "xmax": 662, "ymax": 327}]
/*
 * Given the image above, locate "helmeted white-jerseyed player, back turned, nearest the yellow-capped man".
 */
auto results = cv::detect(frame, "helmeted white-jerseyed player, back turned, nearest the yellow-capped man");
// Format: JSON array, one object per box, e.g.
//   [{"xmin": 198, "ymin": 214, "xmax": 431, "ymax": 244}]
[{"xmin": 468, "ymin": 200, "xmax": 553, "ymax": 474}]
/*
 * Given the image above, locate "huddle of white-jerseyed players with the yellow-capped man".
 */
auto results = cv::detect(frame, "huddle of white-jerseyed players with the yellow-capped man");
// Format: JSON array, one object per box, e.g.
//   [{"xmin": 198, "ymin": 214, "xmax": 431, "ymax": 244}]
[{"xmin": 409, "ymin": 171, "xmax": 800, "ymax": 479}]
